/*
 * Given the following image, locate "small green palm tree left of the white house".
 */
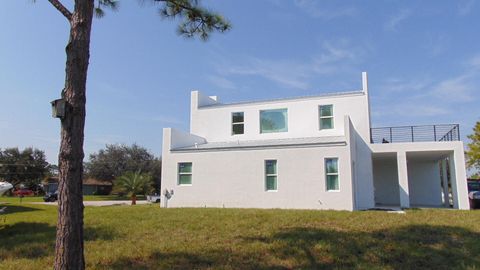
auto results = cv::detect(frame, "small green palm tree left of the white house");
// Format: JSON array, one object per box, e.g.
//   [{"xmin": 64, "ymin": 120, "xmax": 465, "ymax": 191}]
[{"xmin": 116, "ymin": 171, "xmax": 152, "ymax": 205}]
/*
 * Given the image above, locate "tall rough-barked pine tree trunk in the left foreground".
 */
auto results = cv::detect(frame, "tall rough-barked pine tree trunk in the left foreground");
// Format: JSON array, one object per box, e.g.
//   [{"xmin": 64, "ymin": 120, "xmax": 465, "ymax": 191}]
[{"xmin": 54, "ymin": 0, "xmax": 94, "ymax": 269}]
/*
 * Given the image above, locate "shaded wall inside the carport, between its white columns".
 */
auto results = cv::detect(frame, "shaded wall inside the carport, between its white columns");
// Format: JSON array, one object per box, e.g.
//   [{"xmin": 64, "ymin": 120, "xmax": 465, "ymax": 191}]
[{"xmin": 407, "ymin": 160, "xmax": 442, "ymax": 207}]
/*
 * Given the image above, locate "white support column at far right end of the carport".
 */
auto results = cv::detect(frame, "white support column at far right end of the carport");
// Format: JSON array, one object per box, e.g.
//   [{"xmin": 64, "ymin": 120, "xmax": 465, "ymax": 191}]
[{"xmin": 449, "ymin": 151, "xmax": 470, "ymax": 210}]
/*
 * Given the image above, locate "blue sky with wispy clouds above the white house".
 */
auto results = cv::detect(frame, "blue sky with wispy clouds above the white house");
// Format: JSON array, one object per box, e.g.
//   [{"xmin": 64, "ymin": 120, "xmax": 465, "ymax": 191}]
[{"xmin": 0, "ymin": 0, "xmax": 480, "ymax": 163}]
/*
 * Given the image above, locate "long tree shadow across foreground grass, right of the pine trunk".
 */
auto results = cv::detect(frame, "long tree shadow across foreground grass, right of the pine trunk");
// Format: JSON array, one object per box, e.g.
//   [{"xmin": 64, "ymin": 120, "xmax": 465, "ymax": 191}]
[{"xmin": 104, "ymin": 225, "xmax": 480, "ymax": 270}]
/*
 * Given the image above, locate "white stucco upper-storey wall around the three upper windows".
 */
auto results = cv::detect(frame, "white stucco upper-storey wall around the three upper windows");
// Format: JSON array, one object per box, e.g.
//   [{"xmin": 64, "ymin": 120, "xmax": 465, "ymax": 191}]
[{"xmin": 190, "ymin": 91, "xmax": 370, "ymax": 142}]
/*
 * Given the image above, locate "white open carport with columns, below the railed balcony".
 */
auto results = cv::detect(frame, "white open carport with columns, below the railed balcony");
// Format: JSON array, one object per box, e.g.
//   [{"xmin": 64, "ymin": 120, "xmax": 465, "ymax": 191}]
[{"xmin": 372, "ymin": 142, "xmax": 468, "ymax": 209}]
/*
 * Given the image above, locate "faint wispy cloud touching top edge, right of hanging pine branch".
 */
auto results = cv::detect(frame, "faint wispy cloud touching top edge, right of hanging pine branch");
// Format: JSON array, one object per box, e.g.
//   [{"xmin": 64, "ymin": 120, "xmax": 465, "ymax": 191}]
[{"xmin": 294, "ymin": 0, "xmax": 358, "ymax": 20}]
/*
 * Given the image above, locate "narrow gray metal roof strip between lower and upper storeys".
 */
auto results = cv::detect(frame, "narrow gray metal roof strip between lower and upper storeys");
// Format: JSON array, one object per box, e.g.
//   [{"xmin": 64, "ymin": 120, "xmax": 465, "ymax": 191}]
[{"xmin": 171, "ymin": 136, "xmax": 347, "ymax": 152}]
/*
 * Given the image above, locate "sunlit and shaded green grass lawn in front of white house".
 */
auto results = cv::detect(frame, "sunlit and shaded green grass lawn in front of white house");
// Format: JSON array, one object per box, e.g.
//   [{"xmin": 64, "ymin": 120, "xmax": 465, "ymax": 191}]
[{"xmin": 0, "ymin": 203, "xmax": 480, "ymax": 269}]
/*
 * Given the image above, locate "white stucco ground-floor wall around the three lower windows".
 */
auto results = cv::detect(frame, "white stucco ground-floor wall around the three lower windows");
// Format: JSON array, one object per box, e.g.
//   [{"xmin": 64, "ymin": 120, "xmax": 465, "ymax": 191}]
[{"xmin": 162, "ymin": 129, "xmax": 353, "ymax": 210}]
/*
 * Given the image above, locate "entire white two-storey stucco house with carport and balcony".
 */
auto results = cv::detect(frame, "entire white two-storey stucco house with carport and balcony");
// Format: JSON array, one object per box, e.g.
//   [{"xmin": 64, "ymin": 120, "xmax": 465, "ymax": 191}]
[{"xmin": 162, "ymin": 73, "xmax": 468, "ymax": 210}]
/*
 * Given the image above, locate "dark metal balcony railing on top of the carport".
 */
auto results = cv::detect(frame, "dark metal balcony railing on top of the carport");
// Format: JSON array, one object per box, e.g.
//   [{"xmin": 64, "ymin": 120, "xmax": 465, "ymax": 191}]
[{"xmin": 370, "ymin": 124, "xmax": 460, "ymax": 143}]
